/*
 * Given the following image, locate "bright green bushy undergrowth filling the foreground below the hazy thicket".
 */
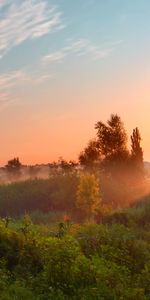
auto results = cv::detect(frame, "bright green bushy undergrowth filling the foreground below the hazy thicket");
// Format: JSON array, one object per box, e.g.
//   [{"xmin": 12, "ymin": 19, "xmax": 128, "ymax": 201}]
[{"xmin": 0, "ymin": 197, "xmax": 150, "ymax": 300}]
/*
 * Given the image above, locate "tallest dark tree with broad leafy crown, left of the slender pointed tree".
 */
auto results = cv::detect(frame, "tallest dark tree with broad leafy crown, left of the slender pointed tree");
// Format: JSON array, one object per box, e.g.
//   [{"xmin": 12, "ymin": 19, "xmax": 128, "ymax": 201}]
[{"xmin": 95, "ymin": 114, "xmax": 130, "ymax": 181}]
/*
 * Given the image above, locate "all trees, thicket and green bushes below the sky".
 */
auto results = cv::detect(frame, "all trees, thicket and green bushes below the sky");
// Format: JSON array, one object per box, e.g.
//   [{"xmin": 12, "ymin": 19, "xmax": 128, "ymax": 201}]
[{"xmin": 0, "ymin": 115, "xmax": 150, "ymax": 300}]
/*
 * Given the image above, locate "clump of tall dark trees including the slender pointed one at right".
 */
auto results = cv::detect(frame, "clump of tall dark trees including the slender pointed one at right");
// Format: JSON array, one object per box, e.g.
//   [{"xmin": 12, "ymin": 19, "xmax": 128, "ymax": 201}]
[{"xmin": 79, "ymin": 114, "xmax": 144, "ymax": 179}]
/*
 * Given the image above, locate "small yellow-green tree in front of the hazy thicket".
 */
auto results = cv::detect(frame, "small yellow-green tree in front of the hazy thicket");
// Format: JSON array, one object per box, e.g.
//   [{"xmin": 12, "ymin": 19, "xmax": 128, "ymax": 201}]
[{"xmin": 76, "ymin": 174, "xmax": 101, "ymax": 220}]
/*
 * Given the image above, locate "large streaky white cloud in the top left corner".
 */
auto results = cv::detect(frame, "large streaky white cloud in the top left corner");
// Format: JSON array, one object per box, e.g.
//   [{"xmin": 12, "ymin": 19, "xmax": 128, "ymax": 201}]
[{"xmin": 0, "ymin": 0, "xmax": 64, "ymax": 57}]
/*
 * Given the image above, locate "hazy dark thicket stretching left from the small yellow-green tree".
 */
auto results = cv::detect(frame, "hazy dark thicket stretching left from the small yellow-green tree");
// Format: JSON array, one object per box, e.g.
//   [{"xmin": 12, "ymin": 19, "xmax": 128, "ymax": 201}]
[{"xmin": 0, "ymin": 173, "xmax": 78, "ymax": 217}]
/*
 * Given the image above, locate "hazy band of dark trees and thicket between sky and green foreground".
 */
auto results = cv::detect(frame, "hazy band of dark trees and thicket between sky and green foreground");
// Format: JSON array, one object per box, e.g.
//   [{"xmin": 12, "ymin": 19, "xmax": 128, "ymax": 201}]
[{"xmin": 0, "ymin": 115, "xmax": 146, "ymax": 222}]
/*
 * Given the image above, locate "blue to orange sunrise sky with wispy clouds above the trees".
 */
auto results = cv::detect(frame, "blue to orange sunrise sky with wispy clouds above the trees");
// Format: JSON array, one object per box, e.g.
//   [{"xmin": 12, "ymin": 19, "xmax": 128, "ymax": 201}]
[{"xmin": 0, "ymin": 0, "xmax": 150, "ymax": 166}]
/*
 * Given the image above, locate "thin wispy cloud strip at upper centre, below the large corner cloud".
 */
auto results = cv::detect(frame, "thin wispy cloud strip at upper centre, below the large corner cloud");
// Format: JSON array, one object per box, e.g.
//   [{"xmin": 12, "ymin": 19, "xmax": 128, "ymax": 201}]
[{"xmin": 42, "ymin": 39, "xmax": 118, "ymax": 64}]
